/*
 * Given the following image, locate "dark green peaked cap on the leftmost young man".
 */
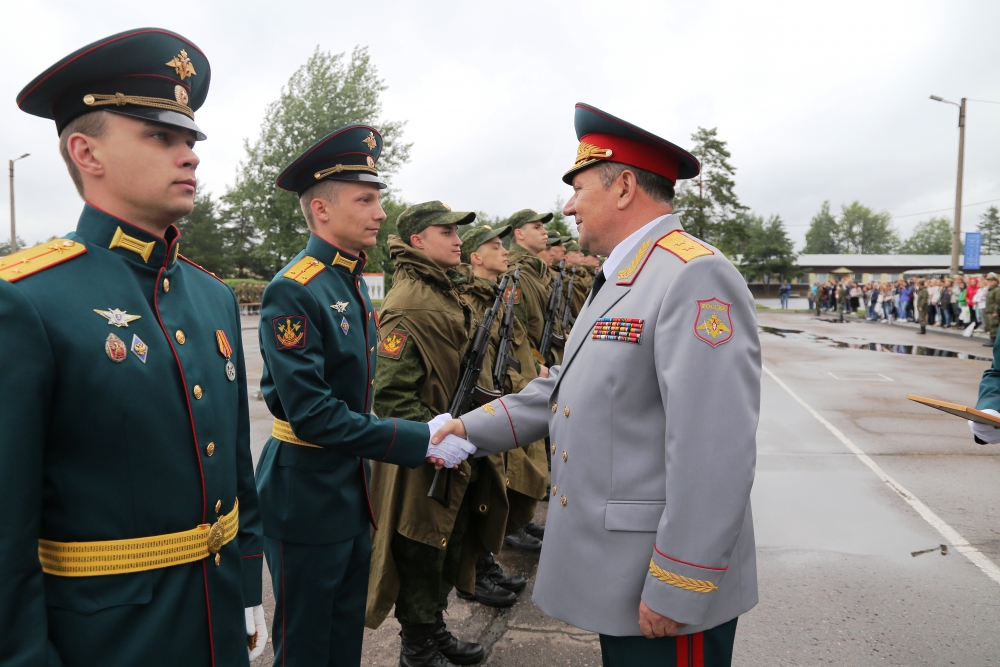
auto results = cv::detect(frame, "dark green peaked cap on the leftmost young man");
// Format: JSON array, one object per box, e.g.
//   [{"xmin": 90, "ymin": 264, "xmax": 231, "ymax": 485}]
[{"xmin": 17, "ymin": 28, "xmax": 212, "ymax": 141}]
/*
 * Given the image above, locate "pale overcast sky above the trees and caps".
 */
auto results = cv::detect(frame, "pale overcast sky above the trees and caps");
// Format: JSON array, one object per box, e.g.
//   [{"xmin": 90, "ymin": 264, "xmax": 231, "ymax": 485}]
[{"xmin": 0, "ymin": 0, "xmax": 1000, "ymax": 249}]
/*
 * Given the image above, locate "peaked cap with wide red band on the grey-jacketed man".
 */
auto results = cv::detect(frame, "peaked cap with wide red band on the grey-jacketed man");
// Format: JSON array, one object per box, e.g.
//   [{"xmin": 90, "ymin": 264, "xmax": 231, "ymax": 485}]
[{"xmin": 563, "ymin": 102, "xmax": 701, "ymax": 185}]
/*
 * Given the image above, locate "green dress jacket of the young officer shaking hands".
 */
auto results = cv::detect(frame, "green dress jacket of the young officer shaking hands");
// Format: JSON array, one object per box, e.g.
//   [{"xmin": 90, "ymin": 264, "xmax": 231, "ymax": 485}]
[{"xmin": 257, "ymin": 236, "xmax": 429, "ymax": 544}]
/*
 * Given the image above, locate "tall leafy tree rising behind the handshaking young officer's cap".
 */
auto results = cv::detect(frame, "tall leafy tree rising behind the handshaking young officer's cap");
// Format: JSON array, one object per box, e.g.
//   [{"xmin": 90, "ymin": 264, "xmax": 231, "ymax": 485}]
[{"xmin": 223, "ymin": 47, "xmax": 412, "ymax": 274}]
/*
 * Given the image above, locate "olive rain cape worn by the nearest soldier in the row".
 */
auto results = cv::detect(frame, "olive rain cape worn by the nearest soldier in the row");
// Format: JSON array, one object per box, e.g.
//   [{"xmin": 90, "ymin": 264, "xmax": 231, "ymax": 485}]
[{"xmin": 365, "ymin": 236, "xmax": 507, "ymax": 628}]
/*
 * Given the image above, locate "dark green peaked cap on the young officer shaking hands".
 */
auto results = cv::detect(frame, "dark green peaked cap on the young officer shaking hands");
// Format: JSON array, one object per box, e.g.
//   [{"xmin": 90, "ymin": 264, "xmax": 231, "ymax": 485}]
[{"xmin": 277, "ymin": 125, "xmax": 388, "ymax": 195}]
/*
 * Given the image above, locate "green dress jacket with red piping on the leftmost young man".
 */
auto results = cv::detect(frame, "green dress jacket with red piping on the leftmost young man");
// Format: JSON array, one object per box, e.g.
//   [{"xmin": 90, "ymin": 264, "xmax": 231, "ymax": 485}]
[{"xmin": 0, "ymin": 205, "xmax": 263, "ymax": 667}]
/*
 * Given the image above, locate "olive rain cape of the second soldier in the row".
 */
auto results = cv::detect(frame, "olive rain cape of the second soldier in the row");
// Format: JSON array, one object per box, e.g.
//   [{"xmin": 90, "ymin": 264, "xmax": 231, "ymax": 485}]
[{"xmin": 459, "ymin": 264, "xmax": 549, "ymax": 530}]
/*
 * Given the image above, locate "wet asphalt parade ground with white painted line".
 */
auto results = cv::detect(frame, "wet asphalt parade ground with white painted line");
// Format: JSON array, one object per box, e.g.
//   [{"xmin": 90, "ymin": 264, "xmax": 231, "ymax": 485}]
[{"xmin": 244, "ymin": 311, "xmax": 1000, "ymax": 666}]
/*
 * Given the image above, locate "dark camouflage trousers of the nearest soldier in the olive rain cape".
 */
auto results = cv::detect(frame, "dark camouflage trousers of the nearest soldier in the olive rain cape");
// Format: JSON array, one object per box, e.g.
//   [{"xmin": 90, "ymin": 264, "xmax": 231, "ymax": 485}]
[{"xmin": 392, "ymin": 459, "xmax": 479, "ymax": 625}]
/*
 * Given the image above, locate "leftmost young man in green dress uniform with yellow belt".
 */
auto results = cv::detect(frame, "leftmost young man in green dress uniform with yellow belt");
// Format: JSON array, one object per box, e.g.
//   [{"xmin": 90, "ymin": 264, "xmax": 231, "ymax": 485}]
[{"xmin": 0, "ymin": 28, "xmax": 266, "ymax": 667}]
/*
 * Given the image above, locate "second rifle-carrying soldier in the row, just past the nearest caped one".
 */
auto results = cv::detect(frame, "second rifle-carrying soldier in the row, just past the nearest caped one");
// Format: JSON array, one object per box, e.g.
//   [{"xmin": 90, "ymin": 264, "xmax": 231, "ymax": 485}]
[{"xmin": 458, "ymin": 226, "xmax": 548, "ymax": 606}]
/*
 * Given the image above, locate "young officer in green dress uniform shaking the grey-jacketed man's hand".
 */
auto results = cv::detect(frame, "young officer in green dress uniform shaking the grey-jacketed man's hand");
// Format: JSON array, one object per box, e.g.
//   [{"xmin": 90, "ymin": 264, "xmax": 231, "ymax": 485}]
[{"xmin": 257, "ymin": 125, "xmax": 470, "ymax": 667}]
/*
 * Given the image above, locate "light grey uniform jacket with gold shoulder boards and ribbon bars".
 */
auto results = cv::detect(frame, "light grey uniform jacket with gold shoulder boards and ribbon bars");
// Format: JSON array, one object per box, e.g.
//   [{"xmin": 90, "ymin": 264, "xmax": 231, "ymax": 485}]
[{"xmin": 462, "ymin": 215, "xmax": 761, "ymax": 636}]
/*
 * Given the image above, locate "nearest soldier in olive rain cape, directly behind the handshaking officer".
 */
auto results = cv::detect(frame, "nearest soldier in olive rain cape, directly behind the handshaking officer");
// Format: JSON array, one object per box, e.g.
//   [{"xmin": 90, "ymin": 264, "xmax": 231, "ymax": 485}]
[{"xmin": 365, "ymin": 201, "xmax": 513, "ymax": 667}]
